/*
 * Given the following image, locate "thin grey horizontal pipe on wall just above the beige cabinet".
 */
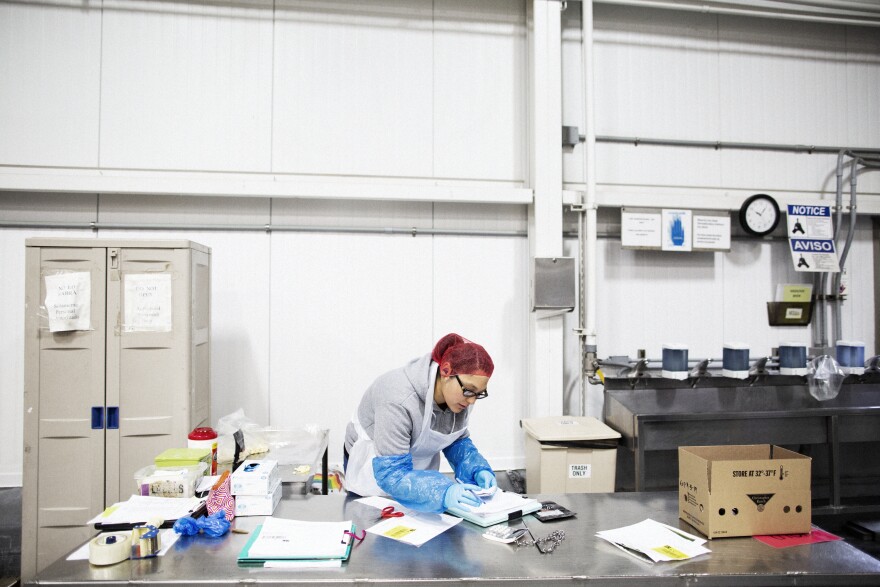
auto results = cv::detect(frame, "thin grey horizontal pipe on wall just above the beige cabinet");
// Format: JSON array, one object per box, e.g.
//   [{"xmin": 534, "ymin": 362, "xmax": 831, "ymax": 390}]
[{"xmin": 0, "ymin": 221, "xmax": 528, "ymax": 237}]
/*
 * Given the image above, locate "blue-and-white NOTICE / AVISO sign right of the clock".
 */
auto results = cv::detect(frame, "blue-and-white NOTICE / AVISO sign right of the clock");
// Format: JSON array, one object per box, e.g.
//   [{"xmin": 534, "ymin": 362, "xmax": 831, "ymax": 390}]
[{"xmin": 788, "ymin": 204, "xmax": 840, "ymax": 272}]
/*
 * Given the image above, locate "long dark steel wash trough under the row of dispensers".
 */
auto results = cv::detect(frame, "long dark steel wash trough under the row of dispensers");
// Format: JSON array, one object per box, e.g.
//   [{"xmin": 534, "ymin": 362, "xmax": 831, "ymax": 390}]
[{"xmin": 605, "ymin": 376, "xmax": 880, "ymax": 513}]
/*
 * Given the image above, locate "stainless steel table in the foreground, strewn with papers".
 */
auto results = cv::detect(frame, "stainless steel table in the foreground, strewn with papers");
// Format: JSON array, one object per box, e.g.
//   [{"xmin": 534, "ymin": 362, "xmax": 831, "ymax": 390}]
[{"xmin": 27, "ymin": 492, "xmax": 880, "ymax": 586}]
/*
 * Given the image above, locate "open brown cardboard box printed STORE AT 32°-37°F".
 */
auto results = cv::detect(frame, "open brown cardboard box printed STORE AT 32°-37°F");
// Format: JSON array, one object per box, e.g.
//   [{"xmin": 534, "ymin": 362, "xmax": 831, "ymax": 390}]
[{"xmin": 678, "ymin": 444, "xmax": 811, "ymax": 538}]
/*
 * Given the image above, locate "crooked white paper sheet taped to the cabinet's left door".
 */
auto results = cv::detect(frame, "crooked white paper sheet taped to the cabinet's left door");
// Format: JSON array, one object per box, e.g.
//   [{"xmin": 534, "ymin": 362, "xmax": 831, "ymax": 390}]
[{"xmin": 44, "ymin": 271, "xmax": 92, "ymax": 332}]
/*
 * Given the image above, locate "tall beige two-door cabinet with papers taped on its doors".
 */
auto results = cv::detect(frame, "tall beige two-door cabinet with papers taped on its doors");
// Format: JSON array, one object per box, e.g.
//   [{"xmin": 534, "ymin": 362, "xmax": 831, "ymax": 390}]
[{"xmin": 21, "ymin": 238, "xmax": 211, "ymax": 580}]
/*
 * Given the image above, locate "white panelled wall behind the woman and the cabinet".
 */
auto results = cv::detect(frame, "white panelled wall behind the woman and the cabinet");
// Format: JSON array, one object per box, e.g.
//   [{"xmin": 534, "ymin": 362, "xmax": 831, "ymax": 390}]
[{"xmin": 0, "ymin": 0, "xmax": 880, "ymax": 485}]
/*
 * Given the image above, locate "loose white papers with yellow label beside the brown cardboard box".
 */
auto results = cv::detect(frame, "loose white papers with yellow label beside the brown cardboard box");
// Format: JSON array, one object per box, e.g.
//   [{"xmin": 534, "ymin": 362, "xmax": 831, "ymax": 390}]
[{"xmin": 596, "ymin": 520, "xmax": 711, "ymax": 562}]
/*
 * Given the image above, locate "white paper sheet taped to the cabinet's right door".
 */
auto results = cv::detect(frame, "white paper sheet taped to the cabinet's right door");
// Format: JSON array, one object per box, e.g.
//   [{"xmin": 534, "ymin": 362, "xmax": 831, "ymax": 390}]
[{"xmin": 122, "ymin": 273, "xmax": 171, "ymax": 332}]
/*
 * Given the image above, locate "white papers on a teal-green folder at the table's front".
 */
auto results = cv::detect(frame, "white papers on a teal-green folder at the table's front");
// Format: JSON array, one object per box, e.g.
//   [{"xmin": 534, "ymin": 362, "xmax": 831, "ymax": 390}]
[{"xmin": 238, "ymin": 517, "xmax": 354, "ymax": 567}]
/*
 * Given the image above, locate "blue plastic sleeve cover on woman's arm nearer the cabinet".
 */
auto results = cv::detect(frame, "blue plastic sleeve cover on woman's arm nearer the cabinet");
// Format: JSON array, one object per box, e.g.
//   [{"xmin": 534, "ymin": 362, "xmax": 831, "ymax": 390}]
[{"xmin": 373, "ymin": 453, "xmax": 452, "ymax": 514}]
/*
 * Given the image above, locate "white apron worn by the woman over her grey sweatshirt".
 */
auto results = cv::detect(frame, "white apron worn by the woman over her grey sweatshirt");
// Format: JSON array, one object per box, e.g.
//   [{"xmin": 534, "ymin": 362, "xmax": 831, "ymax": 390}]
[{"xmin": 345, "ymin": 369, "xmax": 467, "ymax": 496}]
